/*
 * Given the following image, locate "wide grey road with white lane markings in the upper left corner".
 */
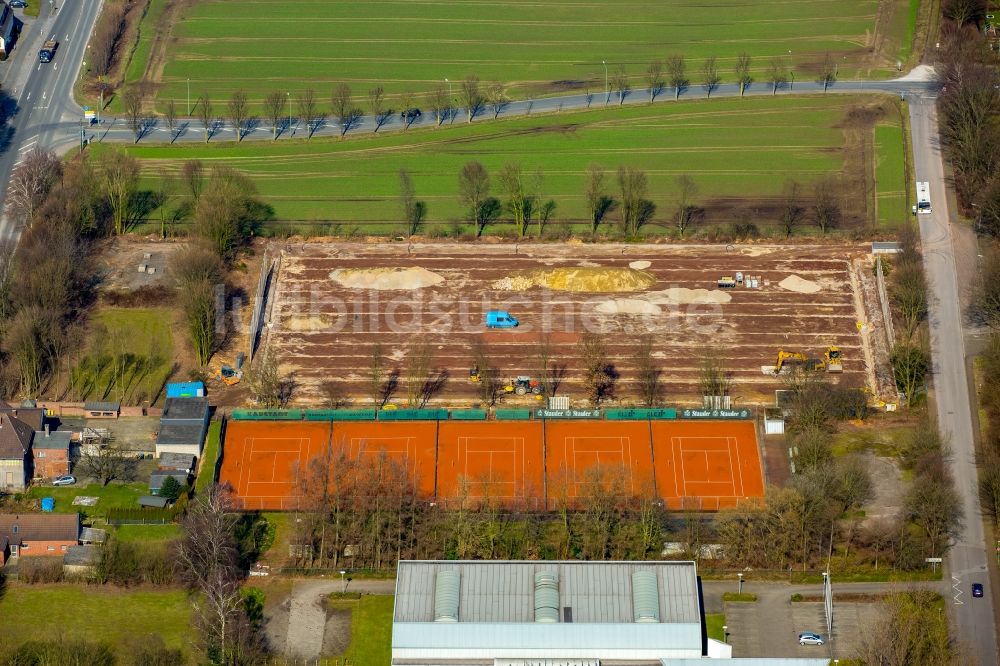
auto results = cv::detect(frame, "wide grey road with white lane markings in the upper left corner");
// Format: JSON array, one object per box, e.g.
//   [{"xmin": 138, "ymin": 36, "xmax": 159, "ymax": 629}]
[{"xmin": 0, "ymin": 0, "xmax": 101, "ymax": 240}]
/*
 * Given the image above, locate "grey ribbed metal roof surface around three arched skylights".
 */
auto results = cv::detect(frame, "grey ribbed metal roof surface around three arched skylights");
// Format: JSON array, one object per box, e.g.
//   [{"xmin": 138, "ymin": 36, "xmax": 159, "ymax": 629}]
[{"xmin": 394, "ymin": 561, "xmax": 701, "ymax": 624}]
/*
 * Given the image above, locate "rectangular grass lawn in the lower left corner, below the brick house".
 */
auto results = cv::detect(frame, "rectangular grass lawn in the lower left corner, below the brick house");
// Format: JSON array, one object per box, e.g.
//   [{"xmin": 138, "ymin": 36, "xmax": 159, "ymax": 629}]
[{"xmin": 0, "ymin": 584, "xmax": 192, "ymax": 653}]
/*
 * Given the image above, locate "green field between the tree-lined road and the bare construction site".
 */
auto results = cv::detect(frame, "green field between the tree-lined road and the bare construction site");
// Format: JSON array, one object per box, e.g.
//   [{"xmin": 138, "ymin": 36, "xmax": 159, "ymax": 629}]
[{"xmin": 123, "ymin": 96, "xmax": 906, "ymax": 233}]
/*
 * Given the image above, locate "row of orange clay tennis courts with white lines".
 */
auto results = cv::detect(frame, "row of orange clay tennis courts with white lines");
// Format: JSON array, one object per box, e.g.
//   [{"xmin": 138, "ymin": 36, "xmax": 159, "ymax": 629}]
[{"xmin": 219, "ymin": 421, "xmax": 764, "ymax": 510}]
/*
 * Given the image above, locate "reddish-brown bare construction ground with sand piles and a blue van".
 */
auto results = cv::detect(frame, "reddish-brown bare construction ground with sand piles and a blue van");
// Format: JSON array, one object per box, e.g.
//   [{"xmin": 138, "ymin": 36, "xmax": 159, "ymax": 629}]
[{"xmin": 263, "ymin": 243, "xmax": 888, "ymax": 404}]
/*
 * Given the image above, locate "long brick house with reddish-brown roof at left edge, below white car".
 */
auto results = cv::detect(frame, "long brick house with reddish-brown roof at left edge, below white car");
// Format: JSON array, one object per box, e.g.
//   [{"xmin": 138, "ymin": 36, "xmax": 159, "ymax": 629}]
[{"xmin": 0, "ymin": 513, "xmax": 80, "ymax": 566}]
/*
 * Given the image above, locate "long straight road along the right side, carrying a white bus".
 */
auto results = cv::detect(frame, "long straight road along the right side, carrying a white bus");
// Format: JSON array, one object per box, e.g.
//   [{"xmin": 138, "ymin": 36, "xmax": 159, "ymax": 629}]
[{"xmin": 910, "ymin": 98, "xmax": 997, "ymax": 666}]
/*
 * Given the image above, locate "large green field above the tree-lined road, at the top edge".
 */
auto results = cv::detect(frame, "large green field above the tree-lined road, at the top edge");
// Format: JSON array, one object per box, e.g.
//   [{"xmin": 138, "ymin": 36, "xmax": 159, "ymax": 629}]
[{"xmin": 145, "ymin": 0, "xmax": 911, "ymax": 108}]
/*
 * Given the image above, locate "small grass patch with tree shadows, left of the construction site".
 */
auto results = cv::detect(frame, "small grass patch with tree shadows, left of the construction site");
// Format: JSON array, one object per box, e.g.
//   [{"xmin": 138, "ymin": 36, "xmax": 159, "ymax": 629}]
[{"xmin": 70, "ymin": 307, "xmax": 174, "ymax": 405}]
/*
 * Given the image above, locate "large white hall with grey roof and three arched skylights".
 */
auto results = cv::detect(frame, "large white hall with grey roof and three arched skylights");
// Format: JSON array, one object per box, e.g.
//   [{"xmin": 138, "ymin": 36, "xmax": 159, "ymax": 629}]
[{"xmin": 392, "ymin": 561, "xmax": 828, "ymax": 666}]
